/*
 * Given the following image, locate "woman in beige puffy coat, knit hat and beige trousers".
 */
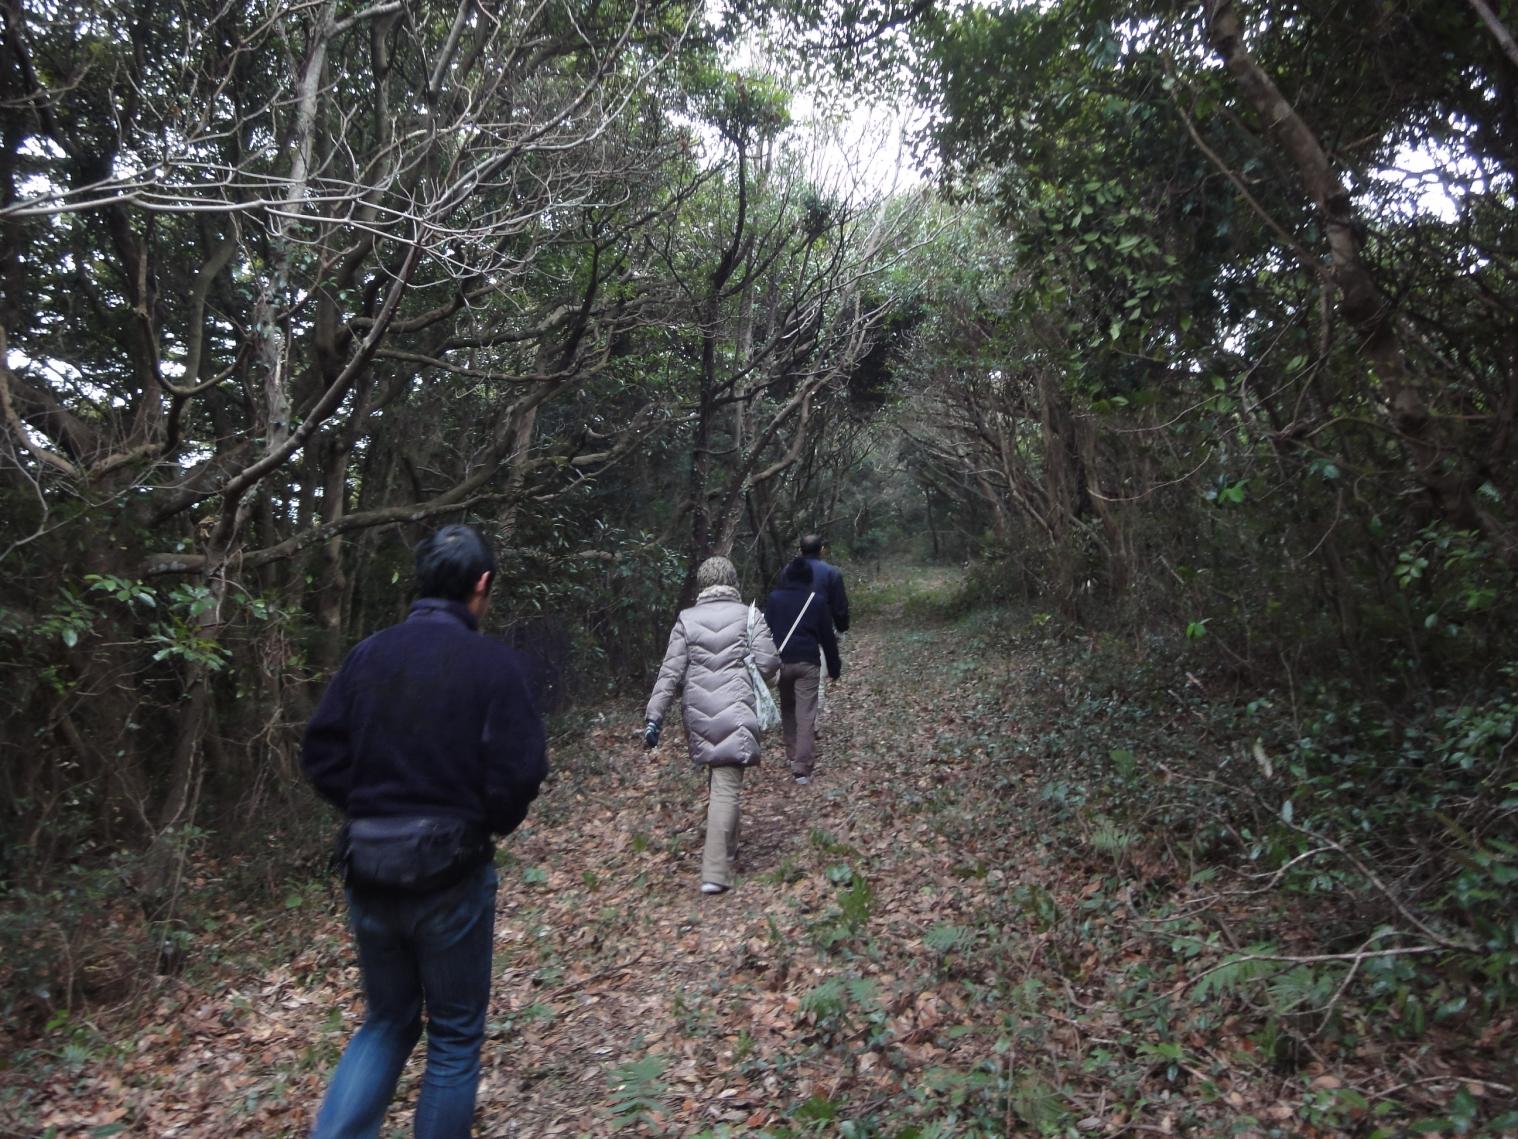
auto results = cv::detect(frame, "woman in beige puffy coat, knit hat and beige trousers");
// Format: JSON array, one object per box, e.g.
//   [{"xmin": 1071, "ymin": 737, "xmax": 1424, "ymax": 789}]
[{"xmin": 644, "ymin": 557, "xmax": 780, "ymax": 894}]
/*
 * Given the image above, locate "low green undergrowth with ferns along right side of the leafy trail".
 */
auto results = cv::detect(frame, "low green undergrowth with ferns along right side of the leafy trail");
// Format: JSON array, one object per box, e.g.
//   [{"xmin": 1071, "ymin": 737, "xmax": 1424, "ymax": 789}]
[{"xmin": 886, "ymin": 571, "xmax": 1518, "ymax": 1134}]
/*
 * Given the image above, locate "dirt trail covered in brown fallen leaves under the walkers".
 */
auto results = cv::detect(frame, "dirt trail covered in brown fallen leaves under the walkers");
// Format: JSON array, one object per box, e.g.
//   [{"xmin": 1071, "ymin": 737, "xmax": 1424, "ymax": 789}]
[{"xmin": 23, "ymin": 574, "xmax": 995, "ymax": 1139}]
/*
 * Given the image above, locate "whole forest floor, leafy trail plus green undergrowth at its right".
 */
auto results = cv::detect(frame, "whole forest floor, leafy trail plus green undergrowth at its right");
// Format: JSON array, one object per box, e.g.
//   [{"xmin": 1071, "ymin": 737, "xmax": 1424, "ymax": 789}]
[{"xmin": 0, "ymin": 570, "xmax": 1518, "ymax": 1139}]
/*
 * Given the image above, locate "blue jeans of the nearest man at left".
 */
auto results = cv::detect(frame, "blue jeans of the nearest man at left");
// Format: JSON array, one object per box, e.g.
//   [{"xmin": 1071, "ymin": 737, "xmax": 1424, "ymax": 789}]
[{"xmin": 311, "ymin": 864, "xmax": 496, "ymax": 1139}]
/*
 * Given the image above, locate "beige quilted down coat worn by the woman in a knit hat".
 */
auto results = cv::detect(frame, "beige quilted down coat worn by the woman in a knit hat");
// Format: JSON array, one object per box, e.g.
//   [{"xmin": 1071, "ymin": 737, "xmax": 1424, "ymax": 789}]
[{"xmin": 645, "ymin": 585, "xmax": 780, "ymax": 767}]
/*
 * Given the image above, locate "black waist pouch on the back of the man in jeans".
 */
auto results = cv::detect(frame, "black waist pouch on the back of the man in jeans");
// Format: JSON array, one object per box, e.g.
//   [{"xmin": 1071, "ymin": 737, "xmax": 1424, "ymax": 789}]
[{"xmin": 342, "ymin": 817, "xmax": 490, "ymax": 894}]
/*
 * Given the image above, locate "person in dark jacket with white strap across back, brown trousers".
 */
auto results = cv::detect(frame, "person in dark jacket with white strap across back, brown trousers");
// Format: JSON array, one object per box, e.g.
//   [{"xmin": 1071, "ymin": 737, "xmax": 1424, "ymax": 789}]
[{"xmin": 764, "ymin": 557, "xmax": 842, "ymax": 784}]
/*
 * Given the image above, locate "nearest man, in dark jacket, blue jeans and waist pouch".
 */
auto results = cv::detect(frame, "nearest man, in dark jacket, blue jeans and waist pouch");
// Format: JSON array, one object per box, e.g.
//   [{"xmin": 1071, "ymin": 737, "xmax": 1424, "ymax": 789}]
[{"xmin": 301, "ymin": 525, "xmax": 548, "ymax": 1139}]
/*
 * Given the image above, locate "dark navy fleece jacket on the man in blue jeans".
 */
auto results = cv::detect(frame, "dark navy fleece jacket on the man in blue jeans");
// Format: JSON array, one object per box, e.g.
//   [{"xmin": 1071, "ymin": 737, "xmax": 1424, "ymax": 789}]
[{"xmin": 301, "ymin": 598, "xmax": 548, "ymax": 835}]
